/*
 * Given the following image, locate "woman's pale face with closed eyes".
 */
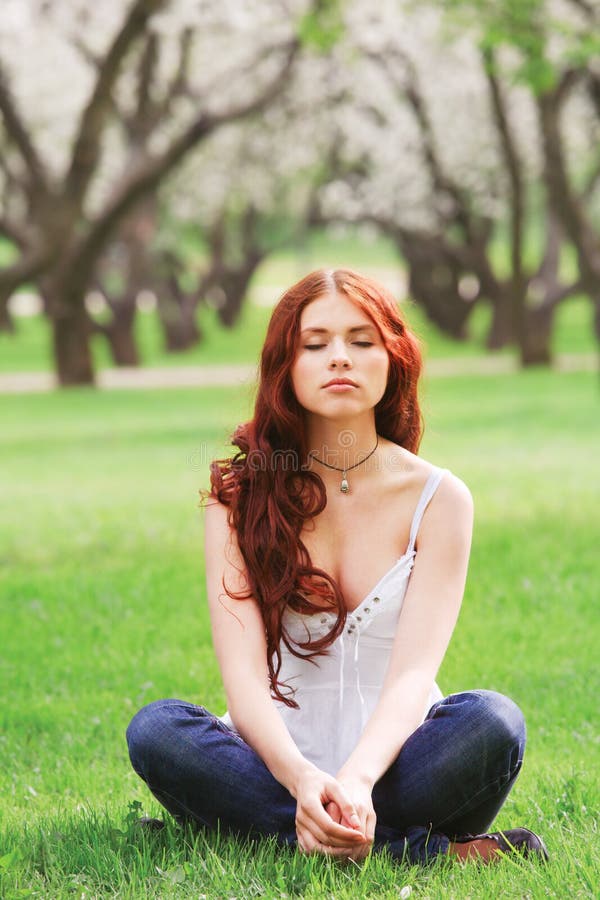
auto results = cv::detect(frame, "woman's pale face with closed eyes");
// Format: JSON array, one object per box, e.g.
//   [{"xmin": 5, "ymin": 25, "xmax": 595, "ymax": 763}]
[{"xmin": 291, "ymin": 294, "xmax": 389, "ymax": 418}]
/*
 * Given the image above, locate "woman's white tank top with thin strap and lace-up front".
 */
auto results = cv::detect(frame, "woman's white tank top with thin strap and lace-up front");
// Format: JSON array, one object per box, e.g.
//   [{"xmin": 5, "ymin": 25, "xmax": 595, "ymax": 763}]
[{"xmin": 221, "ymin": 467, "xmax": 448, "ymax": 775}]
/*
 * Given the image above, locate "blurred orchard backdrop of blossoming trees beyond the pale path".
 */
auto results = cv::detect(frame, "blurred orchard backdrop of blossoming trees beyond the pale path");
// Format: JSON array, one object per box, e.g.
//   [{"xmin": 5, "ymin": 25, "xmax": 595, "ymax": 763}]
[{"xmin": 0, "ymin": 0, "xmax": 600, "ymax": 385}]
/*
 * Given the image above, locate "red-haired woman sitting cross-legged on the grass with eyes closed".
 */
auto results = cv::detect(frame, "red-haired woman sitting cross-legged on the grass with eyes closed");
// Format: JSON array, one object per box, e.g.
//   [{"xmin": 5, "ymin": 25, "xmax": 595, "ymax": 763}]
[{"xmin": 127, "ymin": 270, "xmax": 546, "ymax": 862}]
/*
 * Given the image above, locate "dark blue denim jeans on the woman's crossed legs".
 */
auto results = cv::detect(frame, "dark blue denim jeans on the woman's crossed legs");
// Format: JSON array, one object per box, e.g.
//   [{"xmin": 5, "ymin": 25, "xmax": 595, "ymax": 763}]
[{"xmin": 127, "ymin": 690, "xmax": 525, "ymax": 863}]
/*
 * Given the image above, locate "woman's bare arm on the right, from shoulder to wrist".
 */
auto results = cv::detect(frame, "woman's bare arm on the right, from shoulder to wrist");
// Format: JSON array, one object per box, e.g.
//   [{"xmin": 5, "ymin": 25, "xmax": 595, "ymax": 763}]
[{"xmin": 337, "ymin": 473, "xmax": 473, "ymax": 828}]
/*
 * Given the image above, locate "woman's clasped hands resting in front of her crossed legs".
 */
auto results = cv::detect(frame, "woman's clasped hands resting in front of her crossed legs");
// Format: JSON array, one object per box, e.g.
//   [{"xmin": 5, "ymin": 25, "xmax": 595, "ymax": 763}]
[{"xmin": 296, "ymin": 769, "xmax": 376, "ymax": 860}]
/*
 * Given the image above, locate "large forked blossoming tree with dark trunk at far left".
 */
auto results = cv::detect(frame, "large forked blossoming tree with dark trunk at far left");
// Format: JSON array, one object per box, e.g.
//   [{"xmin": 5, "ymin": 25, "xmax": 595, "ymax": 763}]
[{"xmin": 0, "ymin": 0, "xmax": 326, "ymax": 385}]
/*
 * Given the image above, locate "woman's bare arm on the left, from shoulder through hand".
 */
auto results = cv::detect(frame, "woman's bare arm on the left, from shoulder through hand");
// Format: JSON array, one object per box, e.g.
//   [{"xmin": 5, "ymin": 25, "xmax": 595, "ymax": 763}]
[{"xmin": 205, "ymin": 501, "xmax": 364, "ymax": 852}]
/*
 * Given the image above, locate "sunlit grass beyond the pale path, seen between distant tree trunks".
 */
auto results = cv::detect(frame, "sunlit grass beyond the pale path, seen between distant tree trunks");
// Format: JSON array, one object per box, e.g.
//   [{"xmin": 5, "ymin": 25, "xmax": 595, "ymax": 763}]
[{"xmin": 0, "ymin": 232, "xmax": 597, "ymax": 373}]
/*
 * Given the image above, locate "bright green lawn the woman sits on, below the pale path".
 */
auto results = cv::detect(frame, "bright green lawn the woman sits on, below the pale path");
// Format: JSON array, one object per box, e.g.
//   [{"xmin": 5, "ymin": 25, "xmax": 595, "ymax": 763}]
[{"xmin": 0, "ymin": 371, "xmax": 600, "ymax": 900}]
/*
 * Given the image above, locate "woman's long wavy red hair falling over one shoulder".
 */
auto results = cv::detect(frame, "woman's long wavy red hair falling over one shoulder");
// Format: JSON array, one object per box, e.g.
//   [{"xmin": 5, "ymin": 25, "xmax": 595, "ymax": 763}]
[{"xmin": 201, "ymin": 269, "xmax": 422, "ymax": 707}]
